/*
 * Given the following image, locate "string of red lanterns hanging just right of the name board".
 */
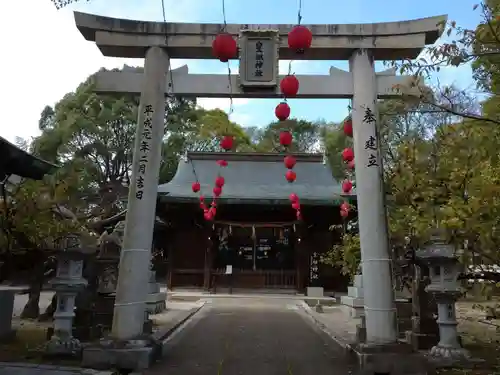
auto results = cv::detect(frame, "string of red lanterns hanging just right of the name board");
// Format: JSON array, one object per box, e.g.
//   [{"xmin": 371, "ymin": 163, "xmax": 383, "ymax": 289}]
[{"xmin": 280, "ymin": 2, "xmax": 312, "ymax": 220}]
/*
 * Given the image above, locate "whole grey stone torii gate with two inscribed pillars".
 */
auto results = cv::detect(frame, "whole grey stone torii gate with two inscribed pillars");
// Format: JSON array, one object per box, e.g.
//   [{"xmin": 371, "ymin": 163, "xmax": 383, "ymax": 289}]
[{"xmin": 75, "ymin": 12, "xmax": 447, "ymax": 345}]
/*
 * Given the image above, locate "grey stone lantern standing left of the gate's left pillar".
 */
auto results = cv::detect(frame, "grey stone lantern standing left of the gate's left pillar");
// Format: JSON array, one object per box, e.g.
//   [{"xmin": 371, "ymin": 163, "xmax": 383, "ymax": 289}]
[{"xmin": 46, "ymin": 234, "xmax": 87, "ymax": 355}]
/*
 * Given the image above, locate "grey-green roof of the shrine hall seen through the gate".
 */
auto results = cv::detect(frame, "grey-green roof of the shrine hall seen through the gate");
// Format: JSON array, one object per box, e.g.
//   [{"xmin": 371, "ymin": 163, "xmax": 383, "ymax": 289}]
[{"xmin": 158, "ymin": 152, "xmax": 352, "ymax": 205}]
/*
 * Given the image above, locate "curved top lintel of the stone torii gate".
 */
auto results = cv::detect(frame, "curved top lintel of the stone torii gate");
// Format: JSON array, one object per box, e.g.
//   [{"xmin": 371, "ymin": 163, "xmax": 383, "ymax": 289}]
[{"xmin": 74, "ymin": 12, "xmax": 447, "ymax": 60}]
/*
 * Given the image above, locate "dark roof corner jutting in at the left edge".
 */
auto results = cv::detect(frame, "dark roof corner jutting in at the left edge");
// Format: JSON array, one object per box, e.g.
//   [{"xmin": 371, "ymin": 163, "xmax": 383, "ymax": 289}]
[{"xmin": 0, "ymin": 137, "xmax": 57, "ymax": 180}]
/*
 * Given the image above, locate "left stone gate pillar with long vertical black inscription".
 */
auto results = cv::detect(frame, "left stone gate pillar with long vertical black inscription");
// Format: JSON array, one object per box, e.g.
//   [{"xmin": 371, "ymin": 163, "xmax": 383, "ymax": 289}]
[{"xmin": 111, "ymin": 46, "xmax": 169, "ymax": 340}]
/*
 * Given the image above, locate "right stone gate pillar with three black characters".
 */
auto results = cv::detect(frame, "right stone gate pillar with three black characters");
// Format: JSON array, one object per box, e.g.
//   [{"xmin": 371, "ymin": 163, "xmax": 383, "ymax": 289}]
[{"xmin": 349, "ymin": 49, "xmax": 397, "ymax": 344}]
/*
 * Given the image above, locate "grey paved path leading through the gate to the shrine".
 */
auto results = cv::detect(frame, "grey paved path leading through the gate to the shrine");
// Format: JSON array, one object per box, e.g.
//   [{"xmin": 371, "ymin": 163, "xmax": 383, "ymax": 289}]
[{"xmin": 144, "ymin": 298, "xmax": 352, "ymax": 375}]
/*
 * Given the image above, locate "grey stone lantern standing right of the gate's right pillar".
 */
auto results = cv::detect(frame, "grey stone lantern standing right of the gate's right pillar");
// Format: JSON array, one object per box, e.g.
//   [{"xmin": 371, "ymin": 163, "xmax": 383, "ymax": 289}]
[{"xmin": 417, "ymin": 233, "xmax": 469, "ymax": 360}]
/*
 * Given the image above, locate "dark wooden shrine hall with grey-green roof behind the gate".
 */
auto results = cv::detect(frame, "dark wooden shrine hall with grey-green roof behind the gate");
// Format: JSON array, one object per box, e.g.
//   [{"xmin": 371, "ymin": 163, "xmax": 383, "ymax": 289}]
[{"xmin": 155, "ymin": 153, "xmax": 354, "ymax": 292}]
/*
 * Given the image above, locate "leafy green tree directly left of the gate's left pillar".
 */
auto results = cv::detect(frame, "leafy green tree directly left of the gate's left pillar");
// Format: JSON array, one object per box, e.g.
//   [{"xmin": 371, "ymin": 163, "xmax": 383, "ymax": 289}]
[{"xmin": 34, "ymin": 79, "xmax": 137, "ymax": 217}]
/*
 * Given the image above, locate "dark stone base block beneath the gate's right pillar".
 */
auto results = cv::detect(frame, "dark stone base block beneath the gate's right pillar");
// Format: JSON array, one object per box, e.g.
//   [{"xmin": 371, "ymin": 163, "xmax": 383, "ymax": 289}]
[{"xmin": 351, "ymin": 342, "xmax": 432, "ymax": 375}]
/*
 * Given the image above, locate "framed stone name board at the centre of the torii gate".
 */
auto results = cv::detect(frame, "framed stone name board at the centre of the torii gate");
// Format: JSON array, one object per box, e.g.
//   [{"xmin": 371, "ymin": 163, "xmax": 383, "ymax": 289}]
[{"xmin": 240, "ymin": 30, "xmax": 279, "ymax": 88}]
